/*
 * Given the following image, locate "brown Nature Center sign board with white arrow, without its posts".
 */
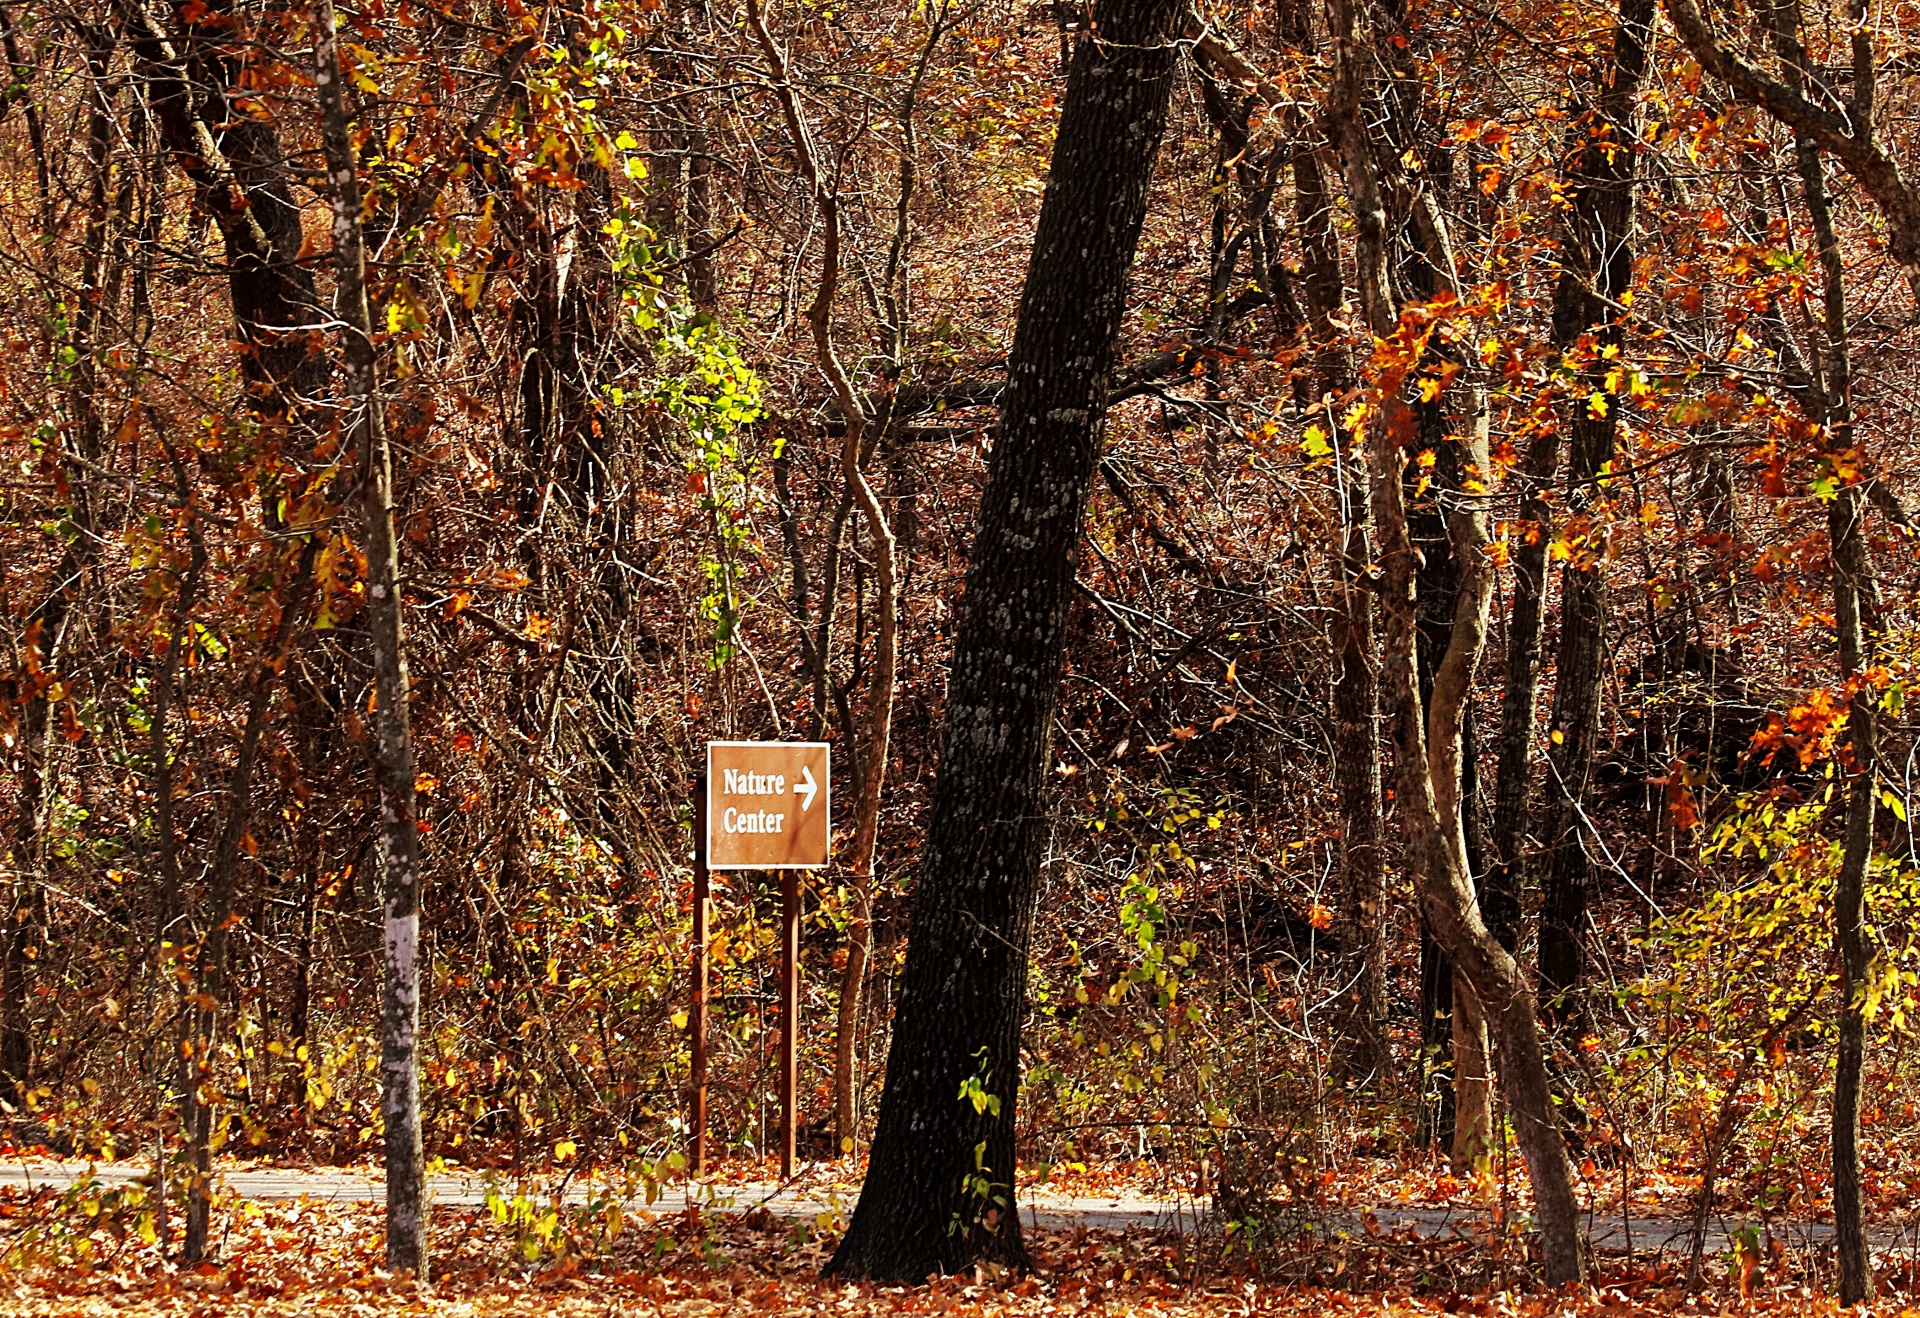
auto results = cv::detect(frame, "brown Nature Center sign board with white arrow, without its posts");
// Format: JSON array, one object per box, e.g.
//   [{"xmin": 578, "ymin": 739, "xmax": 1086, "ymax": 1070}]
[{"xmin": 707, "ymin": 742, "xmax": 831, "ymax": 870}]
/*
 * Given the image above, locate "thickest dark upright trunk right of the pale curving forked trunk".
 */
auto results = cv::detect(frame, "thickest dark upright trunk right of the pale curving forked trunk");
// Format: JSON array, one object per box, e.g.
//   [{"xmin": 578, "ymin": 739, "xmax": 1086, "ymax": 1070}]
[{"xmin": 1515, "ymin": 0, "xmax": 1653, "ymax": 1030}]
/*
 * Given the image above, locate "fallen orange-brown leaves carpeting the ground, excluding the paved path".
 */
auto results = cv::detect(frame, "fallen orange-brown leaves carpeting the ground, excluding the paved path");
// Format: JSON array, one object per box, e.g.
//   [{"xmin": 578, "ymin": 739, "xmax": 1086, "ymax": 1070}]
[{"xmin": 0, "ymin": 1189, "xmax": 1920, "ymax": 1318}]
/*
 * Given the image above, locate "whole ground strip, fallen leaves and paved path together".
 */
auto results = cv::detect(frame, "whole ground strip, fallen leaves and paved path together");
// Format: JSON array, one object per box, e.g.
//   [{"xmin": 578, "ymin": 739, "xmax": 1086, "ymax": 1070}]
[{"xmin": 0, "ymin": 1160, "xmax": 1916, "ymax": 1318}]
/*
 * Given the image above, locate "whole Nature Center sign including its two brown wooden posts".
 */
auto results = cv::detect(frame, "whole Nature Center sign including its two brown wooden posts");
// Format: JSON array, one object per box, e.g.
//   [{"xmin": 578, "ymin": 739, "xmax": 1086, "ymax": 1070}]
[{"xmin": 687, "ymin": 742, "xmax": 833, "ymax": 1180}]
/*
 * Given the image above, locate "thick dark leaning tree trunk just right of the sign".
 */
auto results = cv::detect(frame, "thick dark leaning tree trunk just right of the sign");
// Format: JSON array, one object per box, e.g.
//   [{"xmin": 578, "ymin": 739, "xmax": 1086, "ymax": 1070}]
[{"xmin": 828, "ymin": 0, "xmax": 1179, "ymax": 1281}]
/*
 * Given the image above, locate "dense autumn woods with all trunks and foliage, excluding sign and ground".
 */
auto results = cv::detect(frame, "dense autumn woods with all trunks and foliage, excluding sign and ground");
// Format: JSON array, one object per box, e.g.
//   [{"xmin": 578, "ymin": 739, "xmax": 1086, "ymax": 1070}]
[{"xmin": 11, "ymin": 0, "xmax": 1920, "ymax": 1303}]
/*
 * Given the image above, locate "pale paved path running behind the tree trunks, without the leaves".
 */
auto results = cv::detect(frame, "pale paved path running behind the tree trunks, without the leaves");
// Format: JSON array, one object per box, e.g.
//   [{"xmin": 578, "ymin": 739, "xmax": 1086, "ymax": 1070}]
[{"xmin": 0, "ymin": 1160, "xmax": 1889, "ymax": 1253}]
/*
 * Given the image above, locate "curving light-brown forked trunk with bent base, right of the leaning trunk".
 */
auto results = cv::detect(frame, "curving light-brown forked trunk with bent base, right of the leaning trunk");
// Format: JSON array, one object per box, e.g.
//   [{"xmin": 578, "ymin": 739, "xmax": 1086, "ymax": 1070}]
[{"xmin": 1327, "ymin": 0, "xmax": 1582, "ymax": 1283}]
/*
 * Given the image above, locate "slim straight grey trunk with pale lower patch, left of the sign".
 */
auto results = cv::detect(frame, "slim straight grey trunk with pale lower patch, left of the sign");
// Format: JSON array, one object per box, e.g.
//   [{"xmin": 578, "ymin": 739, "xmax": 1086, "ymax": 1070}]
[{"xmin": 313, "ymin": 0, "xmax": 426, "ymax": 1281}]
